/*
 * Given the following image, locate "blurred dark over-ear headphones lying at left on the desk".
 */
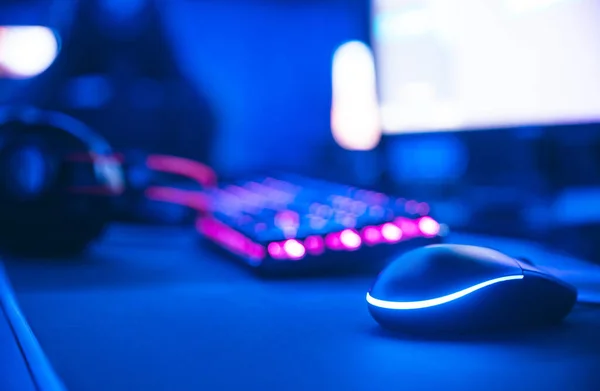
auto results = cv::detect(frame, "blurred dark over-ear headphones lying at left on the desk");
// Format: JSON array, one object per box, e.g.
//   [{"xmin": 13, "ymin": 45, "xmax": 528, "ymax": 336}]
[{"xmin": 0, "ymin": 107, "xmax": 124, "ymax": 256}]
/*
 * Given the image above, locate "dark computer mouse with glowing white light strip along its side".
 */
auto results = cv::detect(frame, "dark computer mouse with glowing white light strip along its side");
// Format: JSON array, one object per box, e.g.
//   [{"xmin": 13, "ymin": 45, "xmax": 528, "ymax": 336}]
[{"xmin": 367, "ymin": 244, "xmax": 577, "ymax": 333}]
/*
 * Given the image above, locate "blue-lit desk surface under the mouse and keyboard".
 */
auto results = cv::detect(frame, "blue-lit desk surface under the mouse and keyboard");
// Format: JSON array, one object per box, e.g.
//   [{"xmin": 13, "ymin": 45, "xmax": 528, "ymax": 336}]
[{"xmin": 6, "ymin": 226, "xmax": 600, "ymax": 391}]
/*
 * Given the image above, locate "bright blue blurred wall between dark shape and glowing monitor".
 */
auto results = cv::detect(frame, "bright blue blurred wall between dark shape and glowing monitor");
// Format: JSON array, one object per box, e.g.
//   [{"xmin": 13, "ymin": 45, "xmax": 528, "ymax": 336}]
[{"xmin": 163, "ymin": 0, "xmax": 365, "ymax": 173}]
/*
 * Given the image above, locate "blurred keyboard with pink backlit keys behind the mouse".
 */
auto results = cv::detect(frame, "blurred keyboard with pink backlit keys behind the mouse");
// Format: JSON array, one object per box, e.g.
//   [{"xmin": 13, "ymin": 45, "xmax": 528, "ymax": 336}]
[{"xmin": 196, "ymin": 176, "xmax": 447, "ymax": 271}]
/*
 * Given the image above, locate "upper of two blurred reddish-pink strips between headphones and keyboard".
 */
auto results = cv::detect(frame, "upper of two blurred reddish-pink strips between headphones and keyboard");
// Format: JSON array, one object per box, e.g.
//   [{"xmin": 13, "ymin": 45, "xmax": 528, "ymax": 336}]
[{"xmin": 146, "ymin": 155, "xmax": 217, "ymax": 186}]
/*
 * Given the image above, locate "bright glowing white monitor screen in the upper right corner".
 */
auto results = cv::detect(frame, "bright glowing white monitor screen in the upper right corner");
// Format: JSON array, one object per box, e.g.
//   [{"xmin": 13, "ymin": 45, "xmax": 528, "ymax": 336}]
[{"xmin": 372, "ymin": 0, "xmax": 600, "ymax": 134}]
